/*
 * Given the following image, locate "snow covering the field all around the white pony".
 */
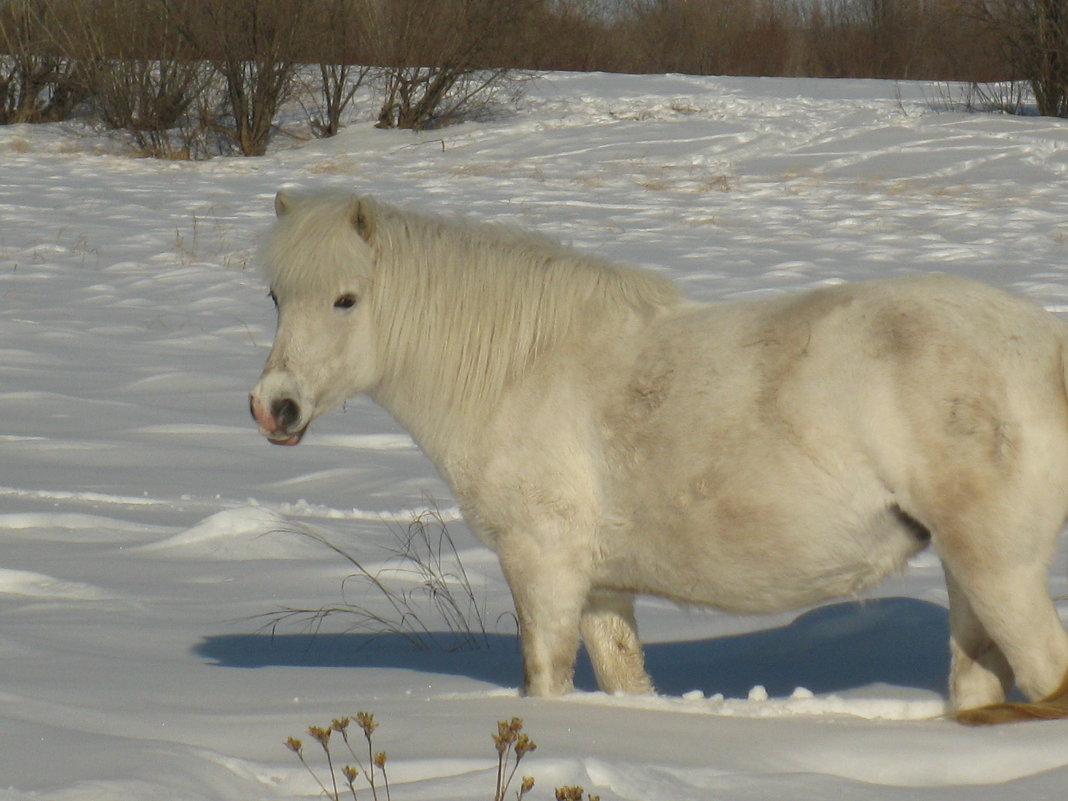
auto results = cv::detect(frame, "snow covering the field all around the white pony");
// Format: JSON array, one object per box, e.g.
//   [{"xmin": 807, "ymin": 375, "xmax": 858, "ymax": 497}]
[{"xmin": 0, "ymin": 75, "xmax": 1068, "ymax": 801}]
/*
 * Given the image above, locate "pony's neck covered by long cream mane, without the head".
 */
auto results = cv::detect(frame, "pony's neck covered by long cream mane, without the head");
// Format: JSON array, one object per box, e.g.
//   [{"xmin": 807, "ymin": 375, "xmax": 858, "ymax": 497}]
[{"xmin": 363, "ymin": 210, "xmax": 678, "ymax": 466}]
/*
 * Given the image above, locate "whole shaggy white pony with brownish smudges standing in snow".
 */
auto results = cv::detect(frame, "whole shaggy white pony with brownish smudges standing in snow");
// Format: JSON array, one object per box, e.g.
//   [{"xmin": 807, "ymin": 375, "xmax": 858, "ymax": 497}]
[{"xmin": 250, "ymin": 194, "xmax": 1068, "ymax": 722}]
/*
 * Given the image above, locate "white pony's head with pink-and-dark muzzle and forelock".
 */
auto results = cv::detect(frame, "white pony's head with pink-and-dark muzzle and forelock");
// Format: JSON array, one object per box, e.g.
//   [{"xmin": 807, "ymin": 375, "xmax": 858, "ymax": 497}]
[{"xmin": 249, "ymin": 192, "xmax": 379, "ymax": 445}]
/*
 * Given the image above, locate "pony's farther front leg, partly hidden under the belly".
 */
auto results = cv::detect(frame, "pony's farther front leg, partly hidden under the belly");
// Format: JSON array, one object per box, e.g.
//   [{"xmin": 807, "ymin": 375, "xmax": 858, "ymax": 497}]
[{"xmin": 582, "ymin": 591, "xmax": 653, "ymax": 694}]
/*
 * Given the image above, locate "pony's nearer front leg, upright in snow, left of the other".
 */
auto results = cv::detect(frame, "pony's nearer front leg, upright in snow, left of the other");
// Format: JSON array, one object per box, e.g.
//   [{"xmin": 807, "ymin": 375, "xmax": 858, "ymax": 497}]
[{"xmin": 498, "ymin": 537, "xmax": 590, "ymax": 696}]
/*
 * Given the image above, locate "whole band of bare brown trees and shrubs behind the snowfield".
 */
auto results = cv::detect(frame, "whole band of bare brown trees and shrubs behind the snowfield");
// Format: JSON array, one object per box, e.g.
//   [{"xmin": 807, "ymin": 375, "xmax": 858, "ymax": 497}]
[{"xmin": 0, "ymin": 0, "xmax": 1050, "ymax": 156}]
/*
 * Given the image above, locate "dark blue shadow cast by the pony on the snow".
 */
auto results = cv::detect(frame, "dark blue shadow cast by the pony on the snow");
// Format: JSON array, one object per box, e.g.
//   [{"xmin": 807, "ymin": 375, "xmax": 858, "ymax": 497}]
[{"xmin": 195, "ymin": 598, "xmax": 948, "ymax": 697}]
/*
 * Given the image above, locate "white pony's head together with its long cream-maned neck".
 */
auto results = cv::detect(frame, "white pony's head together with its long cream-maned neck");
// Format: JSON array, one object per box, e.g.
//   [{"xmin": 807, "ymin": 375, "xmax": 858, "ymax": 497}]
[{"xmin": 250, "ymin": 194, "xmax": 678, "ymax": 447}]
